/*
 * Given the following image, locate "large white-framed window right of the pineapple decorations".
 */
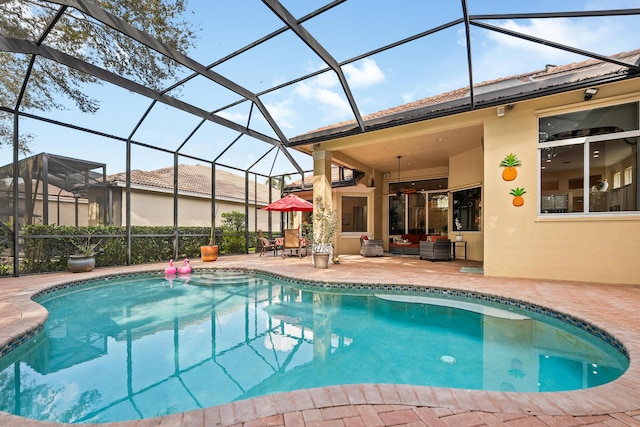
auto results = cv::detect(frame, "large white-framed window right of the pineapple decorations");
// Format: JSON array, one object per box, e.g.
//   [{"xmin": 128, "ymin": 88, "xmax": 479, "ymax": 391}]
[{"xmin": 538, "ymin": 103, "xmax": 640, "ymax": 214}]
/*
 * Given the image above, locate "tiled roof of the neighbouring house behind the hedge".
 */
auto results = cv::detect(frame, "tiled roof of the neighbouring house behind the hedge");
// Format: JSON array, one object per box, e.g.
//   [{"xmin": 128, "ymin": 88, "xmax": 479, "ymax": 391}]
[{"xmin": 107, "ymin": 165, "xmax": 272, "ymax": 205}]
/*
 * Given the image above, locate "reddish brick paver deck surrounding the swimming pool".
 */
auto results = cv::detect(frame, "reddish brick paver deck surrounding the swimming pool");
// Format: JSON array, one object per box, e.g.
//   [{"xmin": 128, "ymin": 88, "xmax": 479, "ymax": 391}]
[{"xmin": 0, "ymin": 254, "xmax": 640, "ymax": 427}]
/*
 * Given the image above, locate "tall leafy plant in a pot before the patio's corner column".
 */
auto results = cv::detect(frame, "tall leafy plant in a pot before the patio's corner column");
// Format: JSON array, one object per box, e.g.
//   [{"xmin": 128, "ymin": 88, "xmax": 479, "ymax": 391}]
[{"xmin": 305, "ymin": 196, "xmax": 338, "ymax": 268}]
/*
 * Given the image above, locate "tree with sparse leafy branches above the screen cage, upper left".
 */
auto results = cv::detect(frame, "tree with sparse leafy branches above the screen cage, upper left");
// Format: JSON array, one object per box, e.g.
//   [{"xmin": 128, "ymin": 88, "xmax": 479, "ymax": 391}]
[{"xmin": 0, "ymin": 0, "xmax": 194, "ymax": 151}]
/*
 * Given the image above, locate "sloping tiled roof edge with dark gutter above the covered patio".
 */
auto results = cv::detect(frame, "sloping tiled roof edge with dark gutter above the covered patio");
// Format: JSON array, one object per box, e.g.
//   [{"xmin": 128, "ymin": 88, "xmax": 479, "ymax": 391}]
[{"xmin": 291, "ymin": 49, "xmax": 640, "ymax": 145}]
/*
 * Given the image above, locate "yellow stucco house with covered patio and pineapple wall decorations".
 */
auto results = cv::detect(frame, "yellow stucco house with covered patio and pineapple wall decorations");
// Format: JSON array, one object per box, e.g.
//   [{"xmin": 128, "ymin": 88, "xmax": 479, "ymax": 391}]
[{"xmin": 292, "ymin": 50, "xmax": 640, "ymax": 284}]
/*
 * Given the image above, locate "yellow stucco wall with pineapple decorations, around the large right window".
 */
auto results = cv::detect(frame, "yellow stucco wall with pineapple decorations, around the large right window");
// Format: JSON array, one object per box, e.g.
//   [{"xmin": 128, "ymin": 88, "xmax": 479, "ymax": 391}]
[{"xmin": 483, "ymin": 79, "xmax": 640, "ymax": 284}]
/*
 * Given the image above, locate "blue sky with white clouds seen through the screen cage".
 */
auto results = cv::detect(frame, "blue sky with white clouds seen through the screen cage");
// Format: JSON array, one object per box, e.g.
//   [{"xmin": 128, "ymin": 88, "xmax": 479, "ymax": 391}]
[{"xmin": 5, "ymin": 0, "xmax": 640, "ymax": 177}]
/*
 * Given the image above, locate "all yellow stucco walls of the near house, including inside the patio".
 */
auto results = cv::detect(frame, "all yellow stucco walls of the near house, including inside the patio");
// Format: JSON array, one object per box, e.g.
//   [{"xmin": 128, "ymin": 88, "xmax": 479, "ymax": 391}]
[{"xmin": 314, "ymin": 79, "xmax": 640, "ymax": 284}]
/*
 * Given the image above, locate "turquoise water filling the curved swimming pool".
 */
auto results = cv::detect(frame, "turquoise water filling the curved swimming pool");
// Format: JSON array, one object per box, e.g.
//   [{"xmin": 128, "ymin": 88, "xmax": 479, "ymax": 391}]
[{"xmin": 0, "ymin": 272, "xmax": 629, "ymax": 423}]
